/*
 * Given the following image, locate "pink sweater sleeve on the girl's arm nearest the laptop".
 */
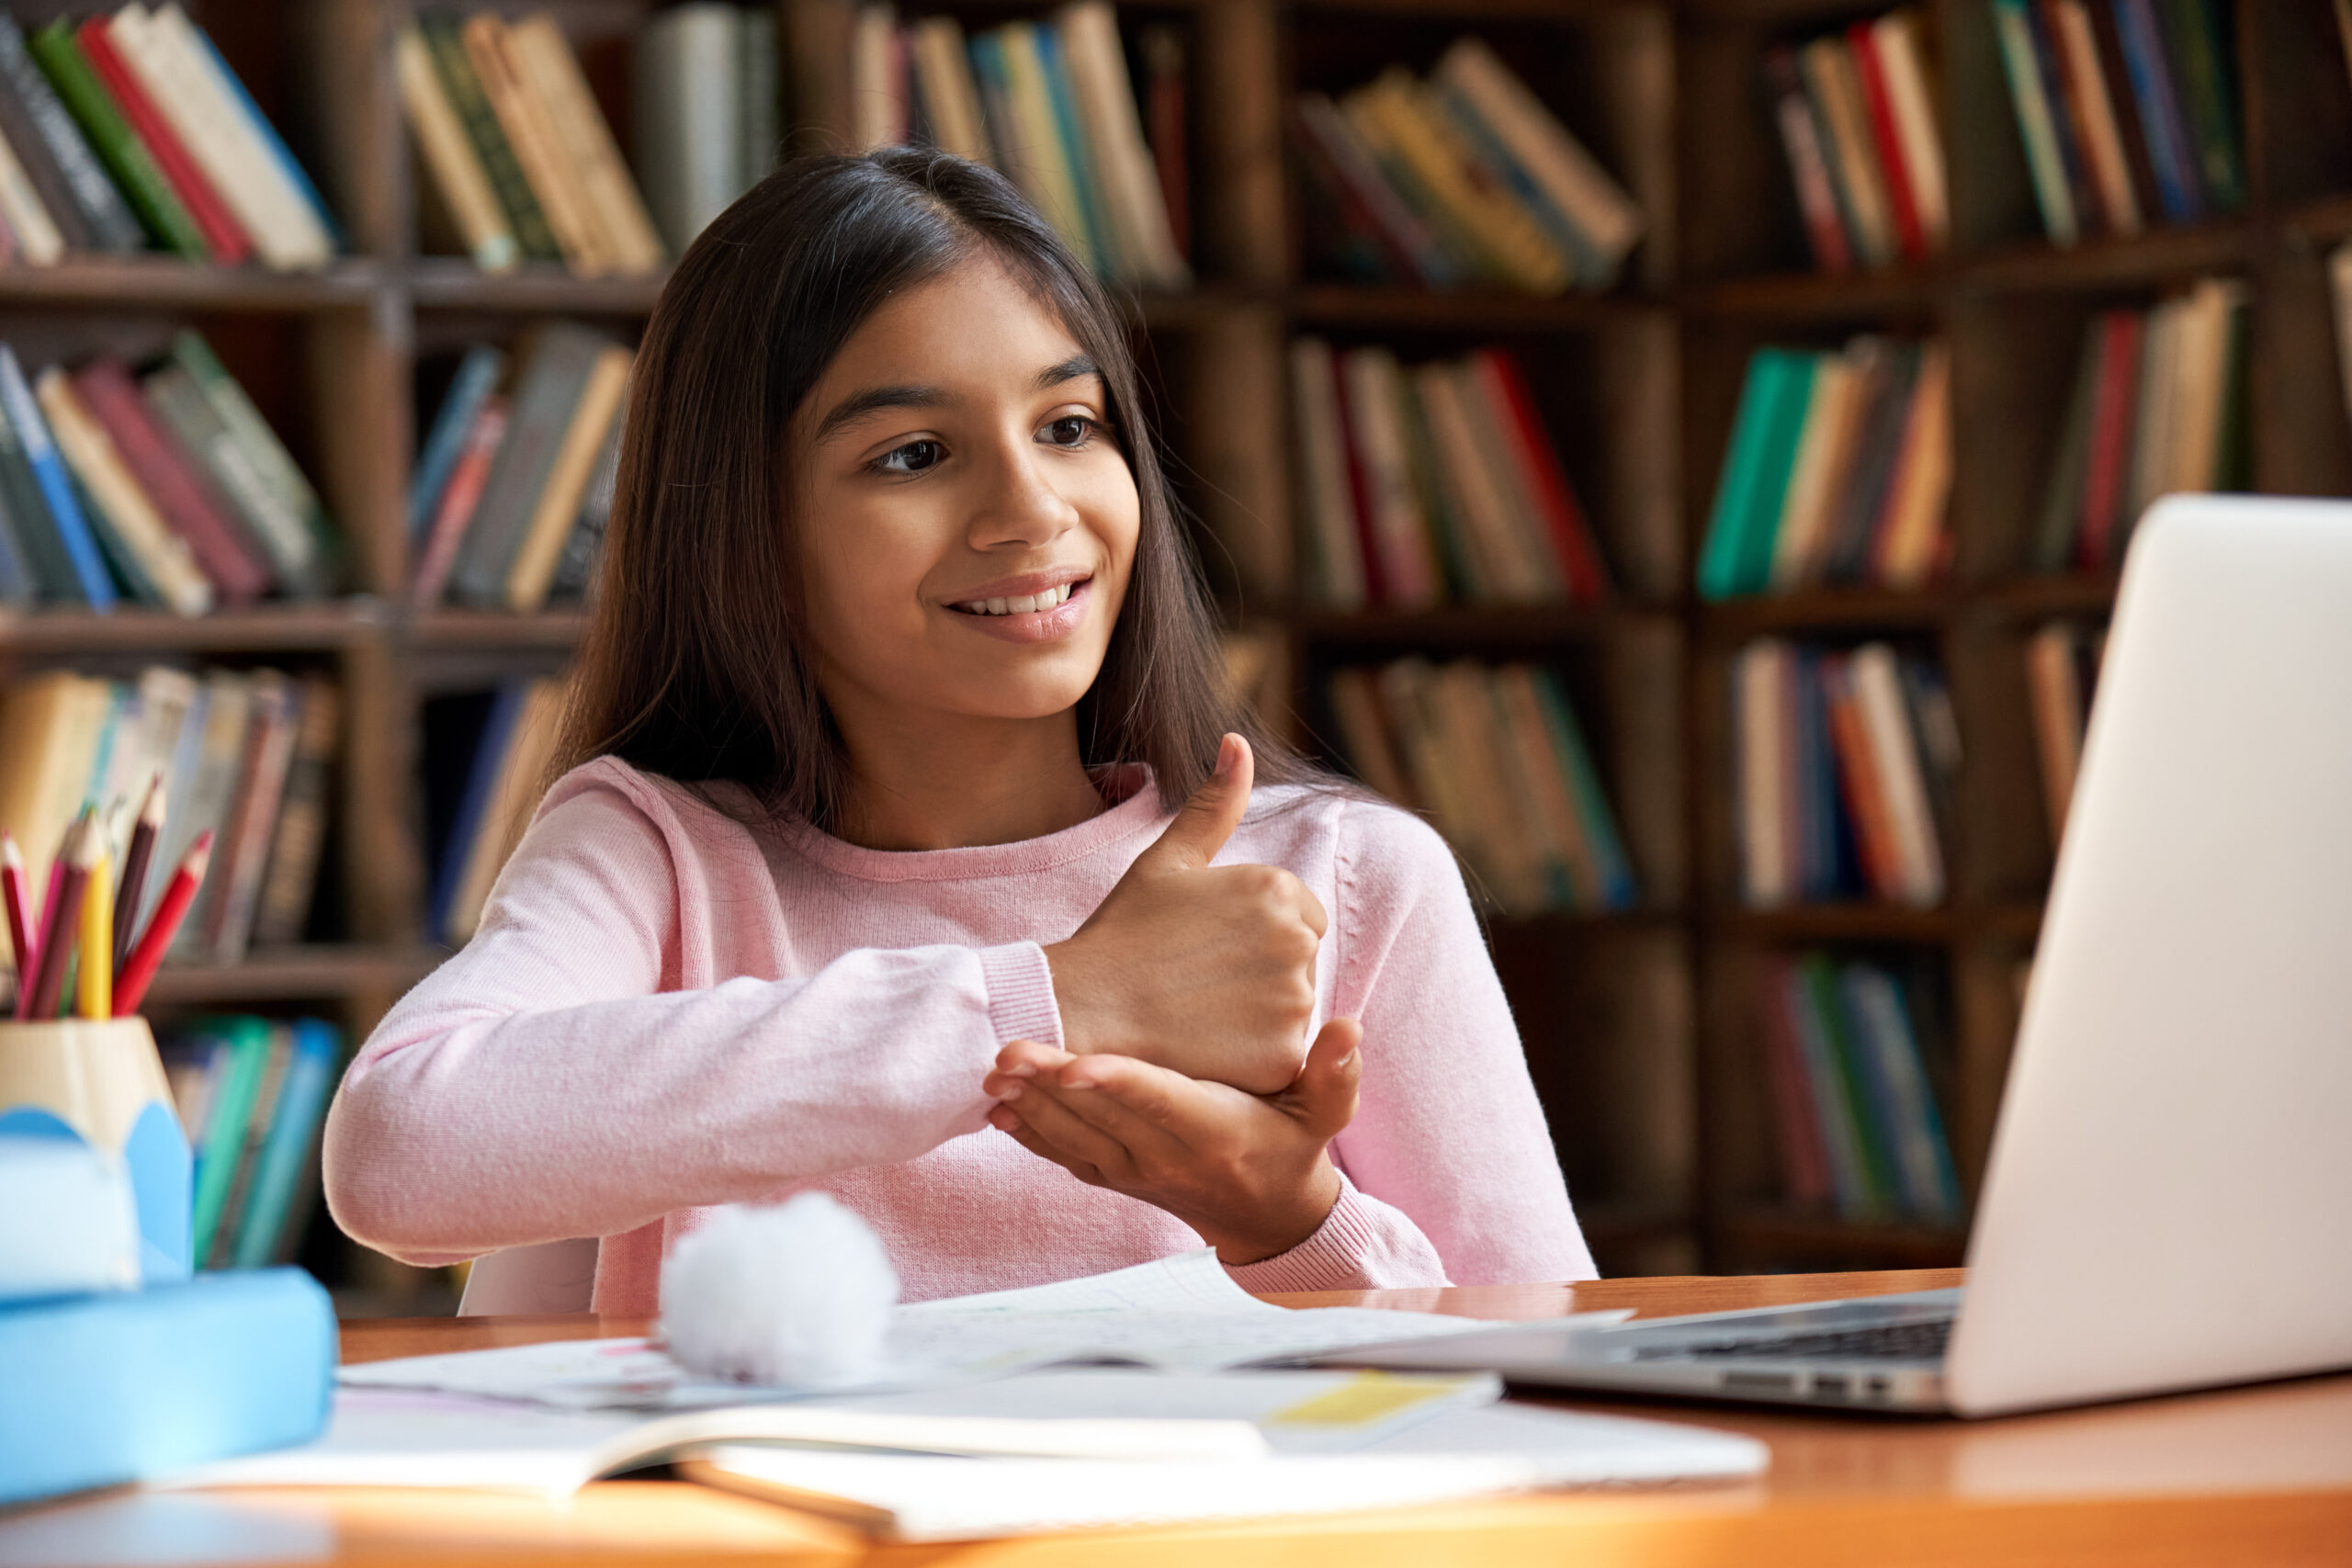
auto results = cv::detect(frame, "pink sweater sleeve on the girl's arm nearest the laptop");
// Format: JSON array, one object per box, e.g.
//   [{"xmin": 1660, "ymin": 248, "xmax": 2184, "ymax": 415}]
[{"xmin": 1307, "ymin": 802, "xmax": 1597, "ymax": 1291}]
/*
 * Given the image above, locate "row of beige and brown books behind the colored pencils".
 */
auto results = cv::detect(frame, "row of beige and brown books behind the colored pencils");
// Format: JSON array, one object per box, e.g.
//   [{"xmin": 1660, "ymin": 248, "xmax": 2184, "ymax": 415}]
[{"xmin": 0, "ymin": 665, "xmax": 341, "ymax": 964}]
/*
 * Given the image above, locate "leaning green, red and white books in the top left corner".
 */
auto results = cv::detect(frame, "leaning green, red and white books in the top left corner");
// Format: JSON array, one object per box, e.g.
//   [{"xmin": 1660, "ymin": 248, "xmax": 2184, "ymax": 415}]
[{"xmin": 0, "ymin": 0, "xmax": 334, "ymax": 273}]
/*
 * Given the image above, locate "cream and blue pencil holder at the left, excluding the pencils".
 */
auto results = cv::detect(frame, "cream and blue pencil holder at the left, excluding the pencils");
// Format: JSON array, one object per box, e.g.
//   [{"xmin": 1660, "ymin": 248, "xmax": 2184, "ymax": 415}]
[{"xmin": 0, "ymin": 1018, "xmax": 193, "ymax": 1286}]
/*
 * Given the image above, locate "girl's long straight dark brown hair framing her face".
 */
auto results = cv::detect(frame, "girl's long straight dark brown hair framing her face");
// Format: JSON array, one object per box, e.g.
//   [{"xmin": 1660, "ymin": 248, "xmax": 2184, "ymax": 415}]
[{"xmin": 560, "ymin": 148, "xmax": 1322, "ymax": 828}]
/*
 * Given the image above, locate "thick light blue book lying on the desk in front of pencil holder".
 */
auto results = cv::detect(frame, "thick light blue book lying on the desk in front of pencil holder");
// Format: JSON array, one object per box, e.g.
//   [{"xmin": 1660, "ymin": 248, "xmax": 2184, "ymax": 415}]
[{"xmin": 0, "ymin": 1269, "xmax": 336, "ymax": 1505}]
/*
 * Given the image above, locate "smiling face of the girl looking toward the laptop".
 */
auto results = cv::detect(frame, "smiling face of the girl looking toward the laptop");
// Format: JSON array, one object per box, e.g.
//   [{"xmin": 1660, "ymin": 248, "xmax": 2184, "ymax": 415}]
[{"xmin": 790, "ymin": 252, "xmax": 1141, "ymax": 733}]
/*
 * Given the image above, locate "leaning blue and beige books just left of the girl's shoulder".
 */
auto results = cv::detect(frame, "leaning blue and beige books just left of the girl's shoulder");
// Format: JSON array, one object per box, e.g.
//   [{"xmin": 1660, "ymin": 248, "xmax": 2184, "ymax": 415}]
[{"xmin": 424, "ymin": 677, "xmax": 567, "ymax": 947}]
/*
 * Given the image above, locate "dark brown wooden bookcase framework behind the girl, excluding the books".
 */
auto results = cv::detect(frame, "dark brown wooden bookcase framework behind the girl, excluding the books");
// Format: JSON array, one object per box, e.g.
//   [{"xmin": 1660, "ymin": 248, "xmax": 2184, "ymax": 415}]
[{"xmin": 0, "ymin": 0, "xmax": 2352, "ymax": 1297}]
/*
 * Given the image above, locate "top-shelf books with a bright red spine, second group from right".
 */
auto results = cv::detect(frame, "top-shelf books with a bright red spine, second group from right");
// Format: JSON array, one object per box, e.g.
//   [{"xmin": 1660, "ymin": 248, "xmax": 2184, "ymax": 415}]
[{"xmin": 1764, "ymin": 9, "xmax": 1952, "ymax": 273}]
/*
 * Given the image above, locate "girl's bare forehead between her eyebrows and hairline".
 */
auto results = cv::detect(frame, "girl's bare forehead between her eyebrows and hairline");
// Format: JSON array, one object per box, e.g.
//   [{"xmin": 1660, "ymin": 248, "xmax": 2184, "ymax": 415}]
[{"xmin": 809, "ymin": 252, "xmax": 1082, "ymax": 394}]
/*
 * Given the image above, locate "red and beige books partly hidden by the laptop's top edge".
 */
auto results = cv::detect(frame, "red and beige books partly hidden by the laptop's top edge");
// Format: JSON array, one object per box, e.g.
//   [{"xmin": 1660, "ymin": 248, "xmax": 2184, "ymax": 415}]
[{"xmin": 2032, "ymin": 277, "xmax": 2253, "ymax": 571}]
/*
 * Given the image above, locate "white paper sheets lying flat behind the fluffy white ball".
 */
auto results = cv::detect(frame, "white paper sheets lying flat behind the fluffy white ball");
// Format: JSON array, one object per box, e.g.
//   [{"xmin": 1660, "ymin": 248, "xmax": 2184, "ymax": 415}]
[{"xmin": 341, "ymin": 1248, "xmax": 1628, "ymax": 1411}]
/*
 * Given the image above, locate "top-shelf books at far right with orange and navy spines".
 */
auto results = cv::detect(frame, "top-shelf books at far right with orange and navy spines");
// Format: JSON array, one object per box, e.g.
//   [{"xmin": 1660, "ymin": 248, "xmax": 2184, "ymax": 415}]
[{"xmin": 1992, "ymin": 0, "xmax": 2246, "ymax": 244}]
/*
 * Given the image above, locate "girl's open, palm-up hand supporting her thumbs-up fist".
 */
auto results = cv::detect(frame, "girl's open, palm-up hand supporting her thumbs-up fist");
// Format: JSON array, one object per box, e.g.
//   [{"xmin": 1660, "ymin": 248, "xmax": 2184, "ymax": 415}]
[{"xmin": 981, "ymin": 1018, "xmax": 1364, "ymax": 1265}]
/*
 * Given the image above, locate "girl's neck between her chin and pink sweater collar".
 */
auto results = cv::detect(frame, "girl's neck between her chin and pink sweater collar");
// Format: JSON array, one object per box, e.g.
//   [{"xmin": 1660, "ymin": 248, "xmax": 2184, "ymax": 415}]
[{"xmin": 832, "ymin": 712, "xmax": 1103, "ymax": 849}]
